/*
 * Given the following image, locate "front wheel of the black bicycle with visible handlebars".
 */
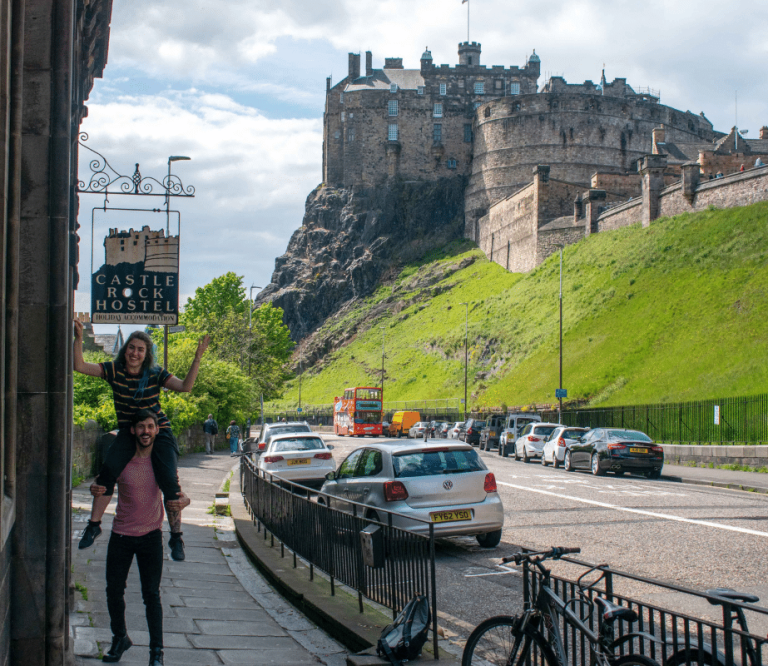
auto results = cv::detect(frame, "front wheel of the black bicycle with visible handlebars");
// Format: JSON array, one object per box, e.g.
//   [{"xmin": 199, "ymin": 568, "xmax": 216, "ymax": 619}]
[{"xmin": 461, "ymin": 615, "xmax": 557, "ymax": 666}]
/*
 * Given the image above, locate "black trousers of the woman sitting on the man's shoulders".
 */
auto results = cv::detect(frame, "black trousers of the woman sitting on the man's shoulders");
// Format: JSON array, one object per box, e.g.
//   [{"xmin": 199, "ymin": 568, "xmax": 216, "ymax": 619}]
[{"xmin": 96, "ymin": 428, "xmax": 181, "ymax": 502}]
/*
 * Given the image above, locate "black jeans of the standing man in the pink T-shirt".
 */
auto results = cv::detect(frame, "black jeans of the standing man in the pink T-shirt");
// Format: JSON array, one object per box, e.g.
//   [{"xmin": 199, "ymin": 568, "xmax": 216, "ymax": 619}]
[{"xmin": 107, "ymin": 530, "xmax": 163, "ymax": 648}]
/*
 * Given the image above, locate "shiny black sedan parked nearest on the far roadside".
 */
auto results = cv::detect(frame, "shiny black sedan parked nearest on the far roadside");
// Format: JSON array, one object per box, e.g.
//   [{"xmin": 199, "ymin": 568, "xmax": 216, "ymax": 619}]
[{"xmin": 563, "ymin": 428, "xmax": 664, "ymax": 479}]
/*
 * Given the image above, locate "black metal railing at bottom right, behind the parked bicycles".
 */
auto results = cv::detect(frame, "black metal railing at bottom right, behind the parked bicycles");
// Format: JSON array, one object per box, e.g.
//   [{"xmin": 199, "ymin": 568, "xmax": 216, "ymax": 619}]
[{"xmin": 523, "ymin": 549, "xmax": 768, "ymax": 666}]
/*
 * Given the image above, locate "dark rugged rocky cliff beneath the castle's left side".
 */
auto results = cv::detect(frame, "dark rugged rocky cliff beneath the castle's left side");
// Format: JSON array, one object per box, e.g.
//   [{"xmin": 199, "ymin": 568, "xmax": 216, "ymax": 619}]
[{"xmin": 257, "ymin": 177, "xmax": 465, "ymax": 341}]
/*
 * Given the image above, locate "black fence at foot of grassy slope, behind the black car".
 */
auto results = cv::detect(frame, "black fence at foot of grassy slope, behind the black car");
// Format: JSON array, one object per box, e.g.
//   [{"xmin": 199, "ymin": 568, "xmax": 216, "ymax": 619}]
[{"xmin": 542, "ymin": 394, "xmax": 768, "ymax": 444}]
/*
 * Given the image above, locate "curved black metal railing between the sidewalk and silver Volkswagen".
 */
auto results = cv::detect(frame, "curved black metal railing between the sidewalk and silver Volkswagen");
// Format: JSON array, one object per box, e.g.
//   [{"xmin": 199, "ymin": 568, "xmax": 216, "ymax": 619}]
[{"xmin": 240, "ymin": 455, "xmax": 439, "ymax": 659}]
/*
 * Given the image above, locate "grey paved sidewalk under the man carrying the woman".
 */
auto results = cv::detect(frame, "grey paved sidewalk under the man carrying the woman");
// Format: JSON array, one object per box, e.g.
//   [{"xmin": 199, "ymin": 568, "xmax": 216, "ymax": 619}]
[{"xmin": 70, "ymin": 452, "xmax": 347, "ymax": 666}]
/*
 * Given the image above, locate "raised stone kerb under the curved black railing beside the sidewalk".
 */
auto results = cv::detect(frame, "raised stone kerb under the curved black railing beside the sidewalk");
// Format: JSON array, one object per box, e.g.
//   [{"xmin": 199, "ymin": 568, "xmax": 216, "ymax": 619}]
[{"xmin": 230, "ymin": 472, "xmax": 459, "ymax": 666}]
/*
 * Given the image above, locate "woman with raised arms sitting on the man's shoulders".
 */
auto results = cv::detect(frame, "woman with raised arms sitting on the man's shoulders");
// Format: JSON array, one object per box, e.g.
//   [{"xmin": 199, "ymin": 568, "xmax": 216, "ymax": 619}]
[{"xmin": 73, "ymin": 320, "xmax": 210, "ymax": 561}]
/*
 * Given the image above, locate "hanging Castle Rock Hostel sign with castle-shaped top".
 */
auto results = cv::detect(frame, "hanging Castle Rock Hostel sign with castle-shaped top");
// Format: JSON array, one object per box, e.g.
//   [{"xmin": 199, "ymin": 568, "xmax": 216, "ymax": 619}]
[{"xmin": 91, "ymin": 226, "xmax": 179, "ymax": 325}]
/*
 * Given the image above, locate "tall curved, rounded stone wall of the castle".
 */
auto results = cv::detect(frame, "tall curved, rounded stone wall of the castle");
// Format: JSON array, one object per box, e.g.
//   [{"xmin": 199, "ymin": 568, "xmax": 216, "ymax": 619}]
[{"xmin": 465, "ymin": 93, "xmax": 715, "ymax": 227}]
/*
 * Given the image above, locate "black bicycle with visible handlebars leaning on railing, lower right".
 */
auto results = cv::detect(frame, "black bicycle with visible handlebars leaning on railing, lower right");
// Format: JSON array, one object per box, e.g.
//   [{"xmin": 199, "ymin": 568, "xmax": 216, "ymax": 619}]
[{"xmin": 461, "ymin": 548, "xmax": 661, "ymax": 666}]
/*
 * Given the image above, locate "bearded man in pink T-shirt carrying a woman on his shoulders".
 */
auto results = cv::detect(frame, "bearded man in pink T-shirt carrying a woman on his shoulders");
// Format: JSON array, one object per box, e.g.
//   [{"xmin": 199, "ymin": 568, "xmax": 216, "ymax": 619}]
[{"xmin": 91, "ymin": 409, "xmax": 190, "ymax": 666}]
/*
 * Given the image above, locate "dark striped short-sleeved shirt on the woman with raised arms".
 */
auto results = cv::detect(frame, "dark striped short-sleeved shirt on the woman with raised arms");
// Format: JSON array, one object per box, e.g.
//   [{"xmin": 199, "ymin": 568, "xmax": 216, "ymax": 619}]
[{"xmin": 100, "ymin": 361, "xmax": 173, "ymax": 428}]
